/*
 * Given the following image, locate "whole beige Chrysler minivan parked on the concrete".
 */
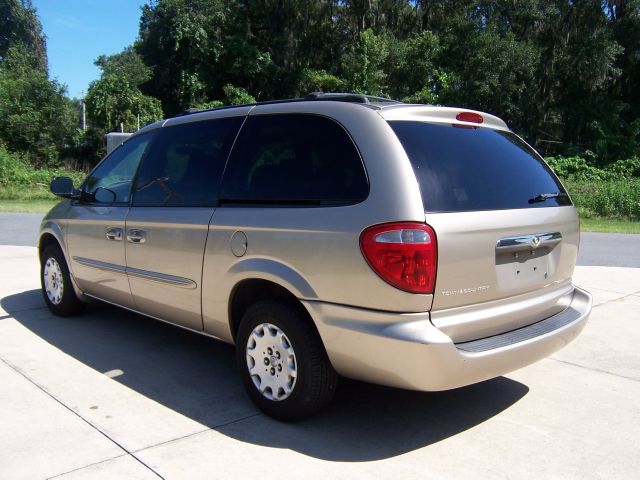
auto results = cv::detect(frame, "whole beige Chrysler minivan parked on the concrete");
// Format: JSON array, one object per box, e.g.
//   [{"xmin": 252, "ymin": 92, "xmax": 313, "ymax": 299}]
[{"xmin": 39, "ymin": 94, "xmax": 591, "ymax": 420}]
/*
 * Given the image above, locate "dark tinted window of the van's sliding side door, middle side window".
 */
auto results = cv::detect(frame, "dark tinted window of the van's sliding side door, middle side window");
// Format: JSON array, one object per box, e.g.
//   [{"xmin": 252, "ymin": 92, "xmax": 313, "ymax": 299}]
[{"xmin": 133, "ymin": 117, "xmax": 243, "ymax": 207}]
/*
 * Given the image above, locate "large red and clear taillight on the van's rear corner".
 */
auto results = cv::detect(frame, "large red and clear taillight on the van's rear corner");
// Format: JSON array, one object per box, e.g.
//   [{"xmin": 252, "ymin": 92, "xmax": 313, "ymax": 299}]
[{"xmin": 360, "ymin": 223, "xmax": 438, "ymax": 293}]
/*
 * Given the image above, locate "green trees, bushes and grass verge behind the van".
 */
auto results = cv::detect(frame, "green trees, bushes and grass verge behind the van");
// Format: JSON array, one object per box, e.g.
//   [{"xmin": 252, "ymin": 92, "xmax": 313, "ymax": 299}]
[{"xmin": 0, "ymin": 0, "xmax": 640, "ymax": 232}]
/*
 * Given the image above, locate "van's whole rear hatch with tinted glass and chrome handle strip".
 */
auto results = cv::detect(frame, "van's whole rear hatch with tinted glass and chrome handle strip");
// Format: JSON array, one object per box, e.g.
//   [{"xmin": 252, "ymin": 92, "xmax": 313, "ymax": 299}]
[{"xmin": 388, "ymin": 109, "xmax": 579, "ymax": 342}]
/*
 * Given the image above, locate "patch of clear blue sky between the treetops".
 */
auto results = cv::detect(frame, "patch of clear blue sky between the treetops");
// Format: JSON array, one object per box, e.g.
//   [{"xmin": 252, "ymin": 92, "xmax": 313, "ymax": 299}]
[{"xmin": 32, "ymin": 0, "xmax": 148, "ymax": 98}]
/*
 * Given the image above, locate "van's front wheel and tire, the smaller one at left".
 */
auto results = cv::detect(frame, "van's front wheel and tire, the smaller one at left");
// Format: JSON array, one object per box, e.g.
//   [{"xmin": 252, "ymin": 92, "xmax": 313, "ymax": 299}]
[{"xmin": 40, "ymin": 245, "xmax": 85, "ymax": 317}]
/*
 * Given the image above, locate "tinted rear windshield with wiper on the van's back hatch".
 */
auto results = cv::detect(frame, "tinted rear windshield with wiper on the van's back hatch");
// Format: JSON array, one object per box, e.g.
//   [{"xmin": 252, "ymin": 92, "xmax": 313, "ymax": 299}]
[{"xmin": 389, "ymin": 121, "xmax": 571, "ymax": 212}]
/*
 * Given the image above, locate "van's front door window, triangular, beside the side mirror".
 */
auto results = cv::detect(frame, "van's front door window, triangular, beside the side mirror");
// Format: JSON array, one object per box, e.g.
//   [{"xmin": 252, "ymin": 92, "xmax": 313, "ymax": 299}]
[{"xmin": 82, "ymin": 133, "xmax": 151, "ymax": 203}]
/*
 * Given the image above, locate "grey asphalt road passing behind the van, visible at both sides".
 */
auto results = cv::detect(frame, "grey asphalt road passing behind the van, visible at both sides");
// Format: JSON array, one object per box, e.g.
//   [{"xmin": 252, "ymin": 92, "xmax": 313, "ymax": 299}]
[{"xmin": 0, "ymin": 212, "xmax": 640, "ymax": 268}]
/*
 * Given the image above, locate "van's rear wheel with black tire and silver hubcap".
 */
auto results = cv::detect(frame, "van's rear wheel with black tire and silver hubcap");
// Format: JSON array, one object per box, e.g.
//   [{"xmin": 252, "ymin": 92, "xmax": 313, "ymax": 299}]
[{"xmin": 236, "ymin": 301, "xmax": 338, "ymax": 421}]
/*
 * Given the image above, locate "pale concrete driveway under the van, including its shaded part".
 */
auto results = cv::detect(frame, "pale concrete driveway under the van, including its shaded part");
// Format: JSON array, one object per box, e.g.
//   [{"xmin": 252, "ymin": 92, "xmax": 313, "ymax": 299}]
[{"xmin": 0, "ymin": 246, "xmax": 640, "ymax": 479}]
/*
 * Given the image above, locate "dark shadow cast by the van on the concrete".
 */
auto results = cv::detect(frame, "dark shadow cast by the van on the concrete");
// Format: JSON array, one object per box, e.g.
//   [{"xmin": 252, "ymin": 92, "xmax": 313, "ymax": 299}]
[{"xmin": 0, "ymin": 290, "xmax": 529, "ymax": 462}]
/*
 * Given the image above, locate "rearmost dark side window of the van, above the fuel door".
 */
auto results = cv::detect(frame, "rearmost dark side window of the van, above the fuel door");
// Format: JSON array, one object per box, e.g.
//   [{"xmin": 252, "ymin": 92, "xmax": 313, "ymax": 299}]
[{"xmin": 220, "ymin": 115, "xmax": 369, "ymax": 205}]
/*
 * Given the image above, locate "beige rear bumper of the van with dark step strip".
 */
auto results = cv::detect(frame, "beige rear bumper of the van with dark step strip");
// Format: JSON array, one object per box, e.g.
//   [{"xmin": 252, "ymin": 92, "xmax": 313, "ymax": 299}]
[{"xmin": 303, "ymin": 288, "xmax": 592, "ymax": 391}]
